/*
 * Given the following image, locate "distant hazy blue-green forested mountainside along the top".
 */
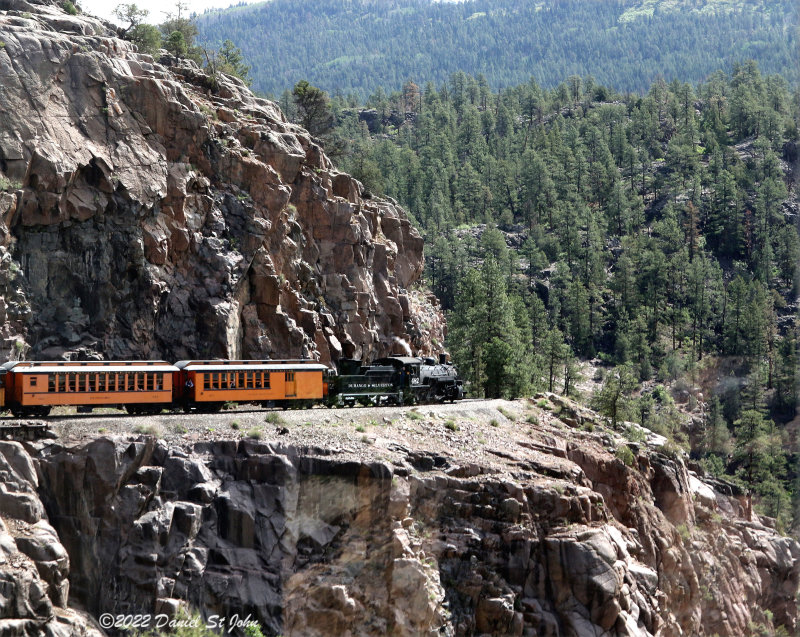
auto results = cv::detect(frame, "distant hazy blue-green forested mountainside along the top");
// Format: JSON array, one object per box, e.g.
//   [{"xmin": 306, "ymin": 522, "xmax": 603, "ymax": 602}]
[{"xmin": 197, "ymin": 0, "xmax": 798, "ymax": 99}]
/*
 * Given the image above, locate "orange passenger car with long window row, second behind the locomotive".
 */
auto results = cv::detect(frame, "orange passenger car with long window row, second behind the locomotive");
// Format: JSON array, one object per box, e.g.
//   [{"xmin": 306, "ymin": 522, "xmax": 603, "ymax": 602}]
[{"xmin": 3, "ymin": 361, "xmax": 177, "ymax": 417}]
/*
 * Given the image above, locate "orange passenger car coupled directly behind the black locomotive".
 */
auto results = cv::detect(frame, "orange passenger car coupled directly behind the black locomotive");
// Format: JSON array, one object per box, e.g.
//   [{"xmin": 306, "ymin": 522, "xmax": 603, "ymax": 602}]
[{"xmin": 175, "ymin": 360, "xmax": 328, "ymax": 411}]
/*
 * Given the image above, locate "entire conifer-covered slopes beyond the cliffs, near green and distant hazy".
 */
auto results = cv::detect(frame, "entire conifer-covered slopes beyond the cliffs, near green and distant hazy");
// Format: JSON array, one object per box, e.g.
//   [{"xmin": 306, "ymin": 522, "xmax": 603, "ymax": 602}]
[{"xmin": 197, "ymin": 0, "xmax": 800, "ymax": 540}]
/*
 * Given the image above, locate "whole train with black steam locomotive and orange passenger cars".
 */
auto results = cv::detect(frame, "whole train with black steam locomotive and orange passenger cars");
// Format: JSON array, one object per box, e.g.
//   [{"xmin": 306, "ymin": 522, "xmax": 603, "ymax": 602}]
[{"xmin": 0, "ymin": 354, "xmax": 464, "ymax": 418}]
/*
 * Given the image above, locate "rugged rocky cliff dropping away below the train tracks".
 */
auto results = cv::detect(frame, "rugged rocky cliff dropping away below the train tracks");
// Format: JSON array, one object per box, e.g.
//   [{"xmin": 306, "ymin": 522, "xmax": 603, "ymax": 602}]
[{"xmin": 0, "ymin": 396, "xmax": 800, "ymax": 637}]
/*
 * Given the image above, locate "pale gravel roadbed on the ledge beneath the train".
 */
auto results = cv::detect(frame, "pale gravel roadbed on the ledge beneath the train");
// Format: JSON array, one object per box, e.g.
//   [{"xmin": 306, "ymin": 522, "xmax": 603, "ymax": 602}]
[{"xmin": 0, "ymin": 399, "xmax": 592, "ymax": 468}]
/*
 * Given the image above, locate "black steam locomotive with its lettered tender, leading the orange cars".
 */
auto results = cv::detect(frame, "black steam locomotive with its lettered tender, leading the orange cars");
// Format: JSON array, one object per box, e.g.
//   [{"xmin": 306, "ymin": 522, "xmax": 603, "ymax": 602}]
[{"xmin": 329, "ymin": 354, "xmax": 464, "ymax": 406}]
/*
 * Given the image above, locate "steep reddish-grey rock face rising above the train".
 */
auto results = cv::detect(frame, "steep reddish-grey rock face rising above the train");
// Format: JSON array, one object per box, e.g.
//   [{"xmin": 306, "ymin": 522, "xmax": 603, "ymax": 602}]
[{"xmin": 0, "ymin": 0, "xmax": 444, "ymax": 362}]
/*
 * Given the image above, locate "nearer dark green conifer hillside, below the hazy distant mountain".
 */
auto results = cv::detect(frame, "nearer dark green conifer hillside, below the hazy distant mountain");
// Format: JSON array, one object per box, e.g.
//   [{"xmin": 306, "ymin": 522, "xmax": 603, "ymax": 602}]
[{"xmin": 320, "ymin": 62, "xmax": 800, "ymax": 521}]
